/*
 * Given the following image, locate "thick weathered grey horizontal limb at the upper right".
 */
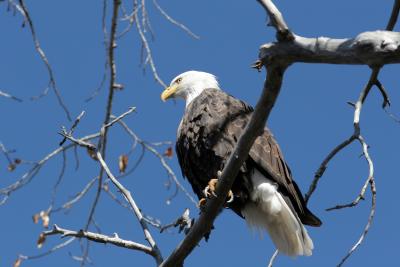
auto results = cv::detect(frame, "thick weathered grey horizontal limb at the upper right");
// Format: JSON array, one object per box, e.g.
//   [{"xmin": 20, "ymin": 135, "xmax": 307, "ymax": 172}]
[{"xmin": 259, "ymin": 31, "xmax": 400, "ymax": 66}]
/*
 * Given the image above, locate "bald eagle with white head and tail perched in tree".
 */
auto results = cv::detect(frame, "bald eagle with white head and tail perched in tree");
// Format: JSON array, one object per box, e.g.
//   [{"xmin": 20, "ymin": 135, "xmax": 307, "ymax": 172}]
[{"xmin": 161, "ymin": 71, "xmax": 321, "ymax": 257}]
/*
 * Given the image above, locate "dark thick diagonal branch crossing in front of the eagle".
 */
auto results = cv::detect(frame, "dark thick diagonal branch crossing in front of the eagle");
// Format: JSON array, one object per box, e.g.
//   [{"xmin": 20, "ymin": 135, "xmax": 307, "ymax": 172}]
[{"xmin": 161, "ymin": 65, "xmax": 286, "ymax": 267}]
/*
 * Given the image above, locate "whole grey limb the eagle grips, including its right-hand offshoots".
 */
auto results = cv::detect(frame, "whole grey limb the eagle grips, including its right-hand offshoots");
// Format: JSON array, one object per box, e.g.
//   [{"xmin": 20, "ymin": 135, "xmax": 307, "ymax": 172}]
[{"xmin": 161, "ymin": 0, "xmax": 400, "ymax": 267}]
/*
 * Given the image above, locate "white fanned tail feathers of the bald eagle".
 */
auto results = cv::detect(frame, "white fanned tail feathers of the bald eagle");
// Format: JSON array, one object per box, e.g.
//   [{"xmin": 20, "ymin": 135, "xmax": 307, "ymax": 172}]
[{"xmin": 242, "ymin": 170, "xmax": 314, "ymax": 257}]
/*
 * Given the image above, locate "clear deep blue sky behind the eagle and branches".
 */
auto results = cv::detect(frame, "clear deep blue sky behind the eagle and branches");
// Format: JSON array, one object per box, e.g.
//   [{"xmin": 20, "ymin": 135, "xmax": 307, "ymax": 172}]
[{"xmin": 0, "ymin": 0, "xmax": 400, "ymax": 266}]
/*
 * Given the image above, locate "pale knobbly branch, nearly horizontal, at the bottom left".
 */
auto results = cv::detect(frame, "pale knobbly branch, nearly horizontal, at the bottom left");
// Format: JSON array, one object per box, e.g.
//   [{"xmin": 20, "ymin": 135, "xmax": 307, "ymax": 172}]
[{"xmin": 43, "ymin": 225, "xmax": 155, "ymax": 256}]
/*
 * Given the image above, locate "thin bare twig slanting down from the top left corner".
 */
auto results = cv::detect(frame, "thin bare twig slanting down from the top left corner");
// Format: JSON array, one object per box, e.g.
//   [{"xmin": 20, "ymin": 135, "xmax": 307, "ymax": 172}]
[{"xmin": 18, "ymin": 0, "xmax": 72, "ymax": 121}]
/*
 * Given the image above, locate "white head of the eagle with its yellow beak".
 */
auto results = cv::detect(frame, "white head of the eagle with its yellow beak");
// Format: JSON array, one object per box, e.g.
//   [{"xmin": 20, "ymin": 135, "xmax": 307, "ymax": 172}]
[{"xmin": 161, "ymin": 70, "xmax": 220, "ymax": 107}]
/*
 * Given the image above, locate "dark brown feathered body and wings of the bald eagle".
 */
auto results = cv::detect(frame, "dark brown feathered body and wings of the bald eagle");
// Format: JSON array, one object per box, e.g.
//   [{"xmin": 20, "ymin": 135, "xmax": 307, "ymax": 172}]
[{"xmin": 176, "ymin": 88, "xmax": 321, "ymax": 226}]
